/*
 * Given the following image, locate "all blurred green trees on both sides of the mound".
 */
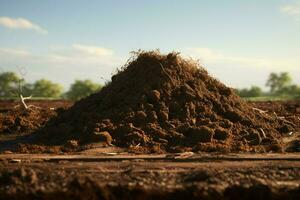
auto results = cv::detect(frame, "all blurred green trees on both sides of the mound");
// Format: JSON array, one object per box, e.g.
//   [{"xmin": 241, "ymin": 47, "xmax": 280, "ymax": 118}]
[{"xmin": 0, "ymin": 72, "xmax": 300, "ymax": 101}]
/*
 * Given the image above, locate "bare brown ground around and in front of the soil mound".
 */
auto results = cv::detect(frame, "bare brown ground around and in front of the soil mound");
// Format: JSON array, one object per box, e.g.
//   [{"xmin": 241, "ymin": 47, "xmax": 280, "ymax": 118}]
[{"xmin": 0, "ymin": 102, "xmax": 300, "ymax": 200}]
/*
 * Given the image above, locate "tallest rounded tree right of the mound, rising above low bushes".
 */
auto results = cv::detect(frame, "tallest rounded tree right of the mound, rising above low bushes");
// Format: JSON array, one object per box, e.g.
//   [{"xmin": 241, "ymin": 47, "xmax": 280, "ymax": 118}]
[{"xmin": 266, "ymin": 72, "xmax": 292, "ymax": 95}]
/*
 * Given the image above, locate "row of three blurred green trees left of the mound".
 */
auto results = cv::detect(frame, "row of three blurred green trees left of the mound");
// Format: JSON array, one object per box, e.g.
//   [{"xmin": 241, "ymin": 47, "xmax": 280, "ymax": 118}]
[{"xmin": 0, "ymin": 72, "xmax": 102, "ymax": 100}]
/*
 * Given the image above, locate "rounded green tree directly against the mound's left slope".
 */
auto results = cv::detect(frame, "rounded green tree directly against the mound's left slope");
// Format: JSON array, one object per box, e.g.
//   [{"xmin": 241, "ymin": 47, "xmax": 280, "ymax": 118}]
[{"xmin": 65, "ymin": 80, "xmax": 102, "ymax": 100}]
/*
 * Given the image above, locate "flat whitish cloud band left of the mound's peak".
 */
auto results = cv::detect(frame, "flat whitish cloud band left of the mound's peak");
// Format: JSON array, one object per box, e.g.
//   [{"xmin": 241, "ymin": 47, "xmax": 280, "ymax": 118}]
[{"xmin": 0, "ymin": 45, "xmax": 121, "ymax": 69}]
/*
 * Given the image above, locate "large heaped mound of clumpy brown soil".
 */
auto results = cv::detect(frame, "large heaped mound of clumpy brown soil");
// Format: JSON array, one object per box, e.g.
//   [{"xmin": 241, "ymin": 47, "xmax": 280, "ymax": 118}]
[{"xmin": 35, "ymin": 51, "xmax": 295, "ymax": 152}]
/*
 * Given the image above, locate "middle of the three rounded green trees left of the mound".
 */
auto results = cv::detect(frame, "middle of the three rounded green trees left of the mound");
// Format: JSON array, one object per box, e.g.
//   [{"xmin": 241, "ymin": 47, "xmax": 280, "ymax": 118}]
[{"xmin": 31, "ymin": 79, "xmax": 63, "ymax": 98}]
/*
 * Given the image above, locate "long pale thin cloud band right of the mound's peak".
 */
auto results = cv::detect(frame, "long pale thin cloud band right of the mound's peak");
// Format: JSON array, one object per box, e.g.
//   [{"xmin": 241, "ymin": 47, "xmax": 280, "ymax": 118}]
[{"xmin": 185, "ymin": 47, "xmax": 300, "ymax": 70}]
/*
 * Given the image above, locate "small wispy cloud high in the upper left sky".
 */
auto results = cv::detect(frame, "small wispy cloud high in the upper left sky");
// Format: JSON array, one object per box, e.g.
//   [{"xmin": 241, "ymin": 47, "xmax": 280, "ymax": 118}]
[{"xmin": 0, "ymin": 17, "xmax": 48, "ymax": 34}]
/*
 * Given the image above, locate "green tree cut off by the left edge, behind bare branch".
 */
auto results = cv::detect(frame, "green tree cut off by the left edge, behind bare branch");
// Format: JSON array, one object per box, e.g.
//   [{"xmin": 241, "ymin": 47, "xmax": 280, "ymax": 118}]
[{"xmin": 0, "ymin": 72, "xmax": 24, "ymax": 97}]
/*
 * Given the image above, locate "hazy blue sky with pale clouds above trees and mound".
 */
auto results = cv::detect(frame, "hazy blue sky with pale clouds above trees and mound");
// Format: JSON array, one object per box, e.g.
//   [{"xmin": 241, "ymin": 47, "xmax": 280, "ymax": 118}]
[{"xmin": 0, "ymin": 0, "xmax": 300, "ymax": 89}]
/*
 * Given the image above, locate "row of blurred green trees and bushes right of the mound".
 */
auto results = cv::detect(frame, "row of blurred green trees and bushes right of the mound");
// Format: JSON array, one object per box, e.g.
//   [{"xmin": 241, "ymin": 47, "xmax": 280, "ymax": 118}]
[{"xmin": 237, "ymin": 72, "xmax": 300, "ymax": 98}]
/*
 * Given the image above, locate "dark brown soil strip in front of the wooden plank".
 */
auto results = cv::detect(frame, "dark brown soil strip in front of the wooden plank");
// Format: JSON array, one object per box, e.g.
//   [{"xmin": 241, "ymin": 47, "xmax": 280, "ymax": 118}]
[{"xmin": 0, "ymin": 155, "xmax": 300, "ymax": 200}]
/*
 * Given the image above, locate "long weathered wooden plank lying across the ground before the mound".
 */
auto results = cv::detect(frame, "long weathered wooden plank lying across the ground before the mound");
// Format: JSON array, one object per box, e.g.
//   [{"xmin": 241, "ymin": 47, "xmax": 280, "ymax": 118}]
[{"xmin": 0, "ymin": 153, "xmax": 300, "ymax": 162}]
